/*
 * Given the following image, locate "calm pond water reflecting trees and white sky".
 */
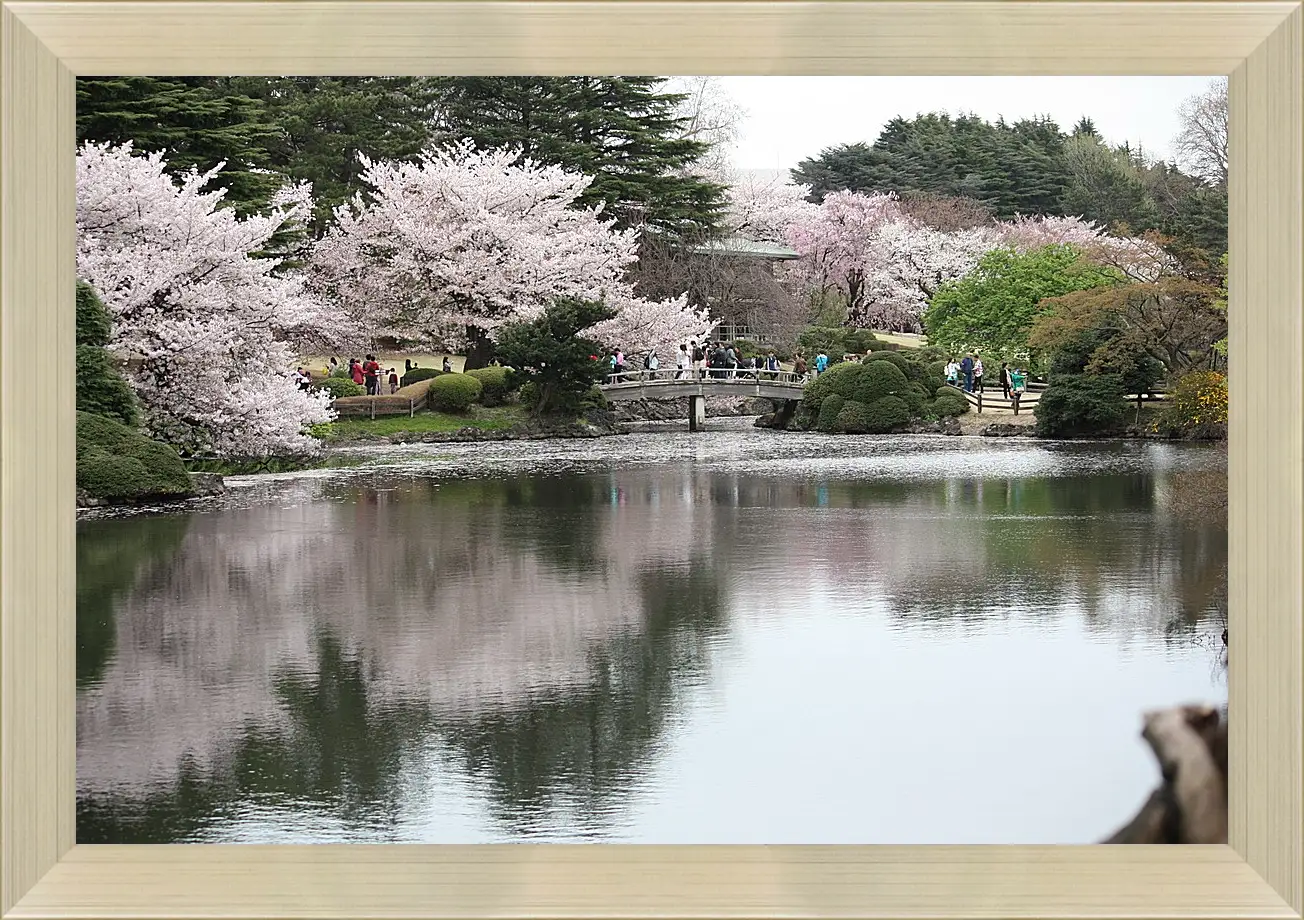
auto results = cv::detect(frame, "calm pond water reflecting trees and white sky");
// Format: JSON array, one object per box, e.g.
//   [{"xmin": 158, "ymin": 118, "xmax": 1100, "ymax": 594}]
[{"xmin": 77, "ymin": 420, "xmax": 1227, "ymax": 843}]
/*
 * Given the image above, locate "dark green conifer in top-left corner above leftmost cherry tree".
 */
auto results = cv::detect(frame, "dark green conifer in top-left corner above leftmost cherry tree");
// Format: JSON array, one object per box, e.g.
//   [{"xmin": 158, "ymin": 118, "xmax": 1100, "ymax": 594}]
[{"xmin": 77, "ymin": 77, "xmax": 282, "ymax": 214}]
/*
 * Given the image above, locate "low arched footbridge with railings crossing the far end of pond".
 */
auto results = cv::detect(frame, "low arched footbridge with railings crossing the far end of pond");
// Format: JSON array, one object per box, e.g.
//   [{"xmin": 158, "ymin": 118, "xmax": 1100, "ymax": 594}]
[{"xmin": 601, "ymin": 367, "xmax": 806, "ymax": 431}]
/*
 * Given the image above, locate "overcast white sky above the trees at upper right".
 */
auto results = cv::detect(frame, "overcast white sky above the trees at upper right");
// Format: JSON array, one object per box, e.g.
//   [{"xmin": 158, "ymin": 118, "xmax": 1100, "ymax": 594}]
[{"xmin": 720, "ymin": 77, "xmax": 1213, "ymax": 169}]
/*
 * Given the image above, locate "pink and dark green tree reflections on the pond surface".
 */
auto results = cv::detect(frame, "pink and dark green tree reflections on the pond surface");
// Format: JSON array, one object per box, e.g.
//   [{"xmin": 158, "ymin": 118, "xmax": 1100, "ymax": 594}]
[{"xmin": 78, "ymin": 458, "xmax": 1226, "ymax": 842}]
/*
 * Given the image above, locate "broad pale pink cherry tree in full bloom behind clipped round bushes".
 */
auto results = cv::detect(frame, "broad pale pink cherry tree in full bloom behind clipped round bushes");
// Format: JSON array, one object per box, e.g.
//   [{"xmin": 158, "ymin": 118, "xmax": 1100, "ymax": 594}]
[{"xmin": 312, "ymin": 142, "xmax": 711, "ymax": 367}]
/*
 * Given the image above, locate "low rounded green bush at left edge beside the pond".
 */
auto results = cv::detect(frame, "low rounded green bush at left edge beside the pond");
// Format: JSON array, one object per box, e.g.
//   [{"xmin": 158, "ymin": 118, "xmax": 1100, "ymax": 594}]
[{"xmin": 77, "ymin": 412, "xmax": 194, "ymax": 500}]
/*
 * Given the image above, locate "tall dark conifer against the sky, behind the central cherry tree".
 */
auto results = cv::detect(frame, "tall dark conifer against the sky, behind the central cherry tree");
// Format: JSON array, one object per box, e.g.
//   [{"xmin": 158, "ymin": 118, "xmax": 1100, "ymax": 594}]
[{"xmin": 437, "ymin": 77, "xmax": 724, "ymax": 233}]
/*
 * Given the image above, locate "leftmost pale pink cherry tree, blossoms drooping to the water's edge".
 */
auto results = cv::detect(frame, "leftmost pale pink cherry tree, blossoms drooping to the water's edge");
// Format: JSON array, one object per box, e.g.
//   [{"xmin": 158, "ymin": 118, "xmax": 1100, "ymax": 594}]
[{"xmin": 77, "ymin": 143, "xmax": 347, "ymax": 457}]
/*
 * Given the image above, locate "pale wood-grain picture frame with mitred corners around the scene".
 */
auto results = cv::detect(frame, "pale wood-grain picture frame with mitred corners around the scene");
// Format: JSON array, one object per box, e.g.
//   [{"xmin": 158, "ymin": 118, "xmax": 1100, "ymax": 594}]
[{"xmin": 0, "ymin": 0, "xmax": 1304, "ymax": 920}]
